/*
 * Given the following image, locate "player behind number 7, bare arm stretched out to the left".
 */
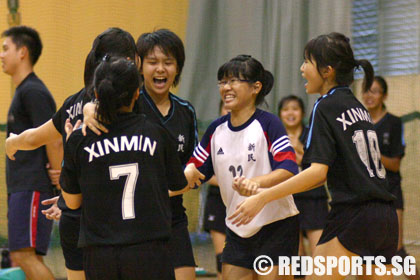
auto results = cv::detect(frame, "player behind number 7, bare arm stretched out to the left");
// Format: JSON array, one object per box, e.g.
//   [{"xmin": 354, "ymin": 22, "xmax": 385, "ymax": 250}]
[{"xmin": 6, "ymin": 28, "xmax": 136, "ymax": 280}]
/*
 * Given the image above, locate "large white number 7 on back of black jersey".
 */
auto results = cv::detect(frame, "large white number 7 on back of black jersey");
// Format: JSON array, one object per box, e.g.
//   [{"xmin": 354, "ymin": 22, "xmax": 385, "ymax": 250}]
[{"xmin": 109, "ymin": 163, "xmax": 139, "ymax": 220}]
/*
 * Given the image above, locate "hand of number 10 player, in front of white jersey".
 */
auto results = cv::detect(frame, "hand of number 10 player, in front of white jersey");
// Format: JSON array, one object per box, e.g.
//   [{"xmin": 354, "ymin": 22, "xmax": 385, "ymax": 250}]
[{"xmin": 228, "ymin": 194, "xmax": 265, "ymax": 226}]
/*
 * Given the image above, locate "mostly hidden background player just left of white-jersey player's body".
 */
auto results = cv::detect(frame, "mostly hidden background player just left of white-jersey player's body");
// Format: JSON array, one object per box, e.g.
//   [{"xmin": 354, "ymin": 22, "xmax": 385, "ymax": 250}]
[{"xmin": 204, "ymin": 100, "xmax": 228, "ymax": 279}]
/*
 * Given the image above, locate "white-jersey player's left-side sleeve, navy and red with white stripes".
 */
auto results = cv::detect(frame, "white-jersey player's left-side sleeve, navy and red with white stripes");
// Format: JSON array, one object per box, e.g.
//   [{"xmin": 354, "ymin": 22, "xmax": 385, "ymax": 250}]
[{"xmin": 188, "ymin": 122, "xmax": 217, "ymax": 182}]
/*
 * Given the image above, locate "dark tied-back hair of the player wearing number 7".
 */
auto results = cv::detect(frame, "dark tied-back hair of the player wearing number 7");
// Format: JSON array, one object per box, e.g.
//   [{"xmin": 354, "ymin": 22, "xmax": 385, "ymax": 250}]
[{"xmin": 94, "ymin": 58, "xmax": 139, "ymax": 123}]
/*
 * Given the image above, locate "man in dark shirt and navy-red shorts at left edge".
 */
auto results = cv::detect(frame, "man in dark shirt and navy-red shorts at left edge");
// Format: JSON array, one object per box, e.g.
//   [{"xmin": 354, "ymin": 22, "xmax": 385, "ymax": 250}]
[{"xmin": 0, "ymin": 26, "xmax": 62, "ymax": 280}]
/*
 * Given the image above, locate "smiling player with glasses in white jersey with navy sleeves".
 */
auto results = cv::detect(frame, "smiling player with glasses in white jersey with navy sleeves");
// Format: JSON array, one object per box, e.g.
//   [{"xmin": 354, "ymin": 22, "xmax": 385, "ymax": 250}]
[{"xmin": 190, "ymin": 55, "xmax": 299, "ymax": 279}]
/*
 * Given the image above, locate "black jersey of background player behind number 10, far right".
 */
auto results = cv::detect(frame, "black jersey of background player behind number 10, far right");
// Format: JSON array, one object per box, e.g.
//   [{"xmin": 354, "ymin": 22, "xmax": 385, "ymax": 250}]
[{"xmin": 374, "ymin": 113, "xmax": 405, "ymax": 188}]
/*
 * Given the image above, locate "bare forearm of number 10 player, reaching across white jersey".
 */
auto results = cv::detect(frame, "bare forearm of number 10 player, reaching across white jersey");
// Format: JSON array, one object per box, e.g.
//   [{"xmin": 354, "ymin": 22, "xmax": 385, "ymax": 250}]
[{"xmin": 258, "ymin": 163, "xmax": 328, "ymax": 203}]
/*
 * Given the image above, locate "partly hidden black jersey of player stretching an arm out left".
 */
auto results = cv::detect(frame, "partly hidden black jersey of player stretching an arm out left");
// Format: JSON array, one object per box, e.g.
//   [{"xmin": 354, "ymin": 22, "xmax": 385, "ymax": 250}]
[{"xmin": 52, "ymin": 88, "xmax": 90, "ymax": 217}]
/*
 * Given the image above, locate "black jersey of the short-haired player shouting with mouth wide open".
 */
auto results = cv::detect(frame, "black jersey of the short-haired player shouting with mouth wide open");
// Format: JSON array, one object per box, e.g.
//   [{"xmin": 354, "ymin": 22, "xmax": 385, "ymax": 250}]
[{"xmin": 133, "ymin": 87, "xmax": 198, "ymax": 221}]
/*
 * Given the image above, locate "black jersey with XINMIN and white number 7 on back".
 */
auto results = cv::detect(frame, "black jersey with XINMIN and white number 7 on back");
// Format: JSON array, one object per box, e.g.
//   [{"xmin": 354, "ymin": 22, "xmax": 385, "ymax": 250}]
[{"xmin": 61, "ymin": 113, "xmax": 187, "ymax": 247}]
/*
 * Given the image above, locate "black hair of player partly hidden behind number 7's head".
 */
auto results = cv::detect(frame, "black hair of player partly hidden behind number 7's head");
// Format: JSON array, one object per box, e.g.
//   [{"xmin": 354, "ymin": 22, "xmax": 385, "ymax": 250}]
[{"xmin": 84, "ymin": 27, "xmax": 136, "ymax": 97}]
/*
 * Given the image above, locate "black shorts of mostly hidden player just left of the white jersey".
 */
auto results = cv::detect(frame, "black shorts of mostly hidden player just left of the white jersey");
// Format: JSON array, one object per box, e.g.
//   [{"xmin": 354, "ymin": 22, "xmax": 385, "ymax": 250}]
[{"xmin": 204, "ymin": 190, "xmax": 226, "ymax": 233}]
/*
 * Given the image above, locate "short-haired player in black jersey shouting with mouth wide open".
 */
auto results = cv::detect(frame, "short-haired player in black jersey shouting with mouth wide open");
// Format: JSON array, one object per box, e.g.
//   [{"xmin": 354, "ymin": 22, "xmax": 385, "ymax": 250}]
[{"xmin": 84, "ymin": 29, "xmax": 198, "ymax": 280}]
